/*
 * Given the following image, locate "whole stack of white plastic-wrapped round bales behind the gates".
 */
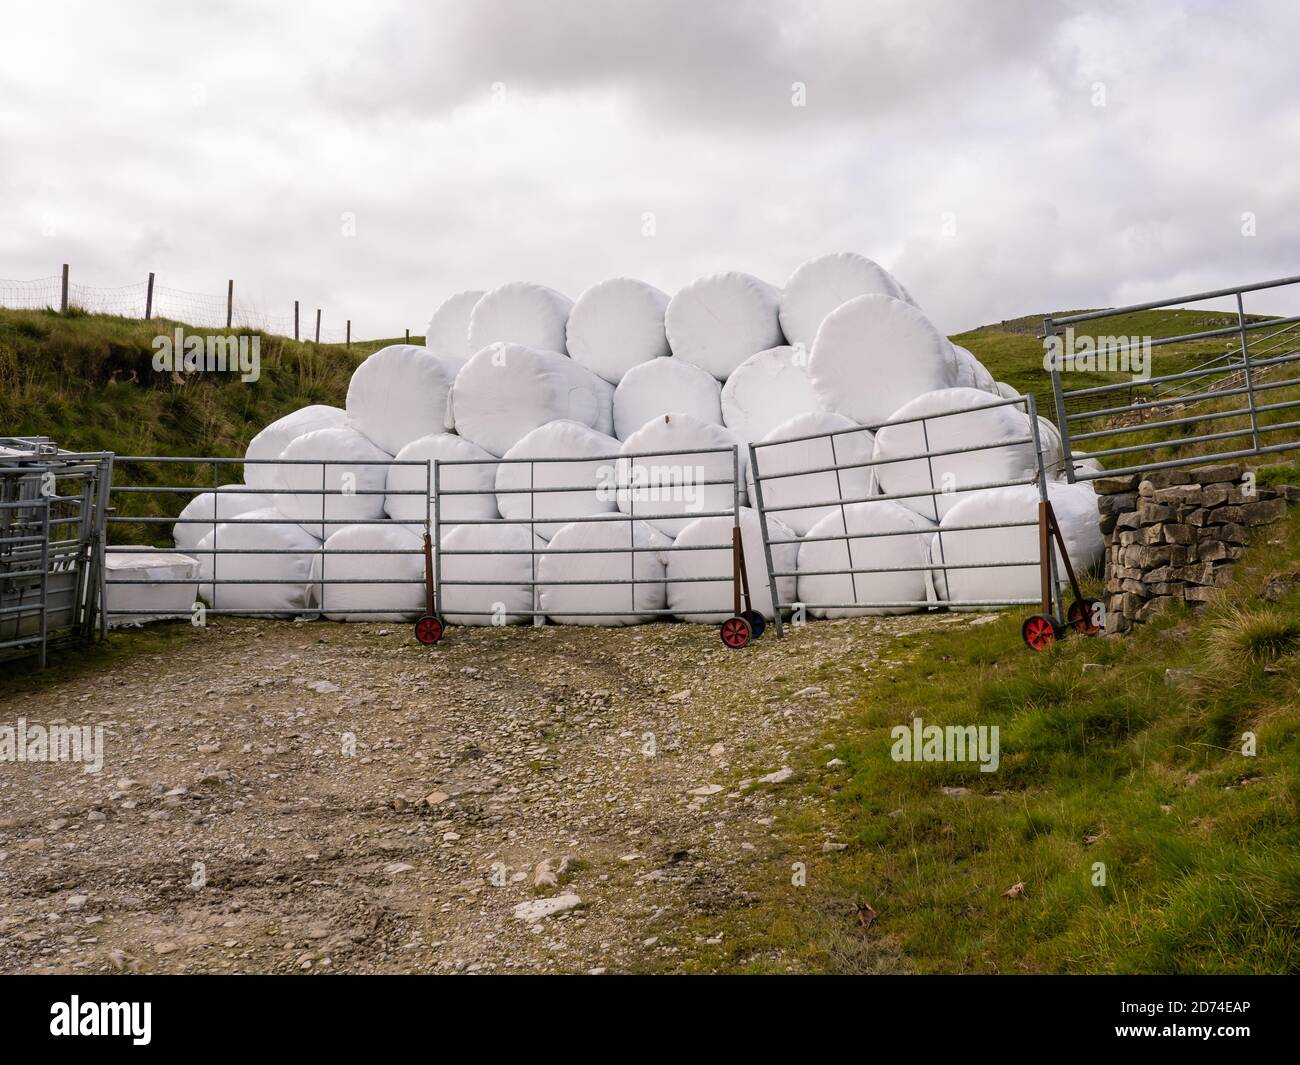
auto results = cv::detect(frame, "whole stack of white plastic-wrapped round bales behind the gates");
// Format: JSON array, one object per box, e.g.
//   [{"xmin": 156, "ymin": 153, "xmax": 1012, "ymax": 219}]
[{"xmin": 176, "ymin": 252, "xmax": 1100, "ymax": 624}]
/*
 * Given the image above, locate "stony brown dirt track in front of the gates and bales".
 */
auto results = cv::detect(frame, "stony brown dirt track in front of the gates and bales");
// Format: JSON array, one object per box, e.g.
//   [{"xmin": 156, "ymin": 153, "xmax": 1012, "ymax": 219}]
[{"xmin": 0, "ymin": 615, "xmax": 970, "ymax": 973}]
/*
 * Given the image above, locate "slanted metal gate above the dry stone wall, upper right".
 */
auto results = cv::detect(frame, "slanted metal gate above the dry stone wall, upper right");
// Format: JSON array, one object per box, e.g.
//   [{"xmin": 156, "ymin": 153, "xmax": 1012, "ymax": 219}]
[{"xmin": 1043, "ymin": 277, "xmax": 1300, "ymax": 481}]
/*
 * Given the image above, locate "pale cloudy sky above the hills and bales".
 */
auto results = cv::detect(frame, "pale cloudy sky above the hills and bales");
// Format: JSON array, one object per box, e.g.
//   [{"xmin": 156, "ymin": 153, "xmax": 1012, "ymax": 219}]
[{"xmin": 0, "ymin": 0, "xmax": 1300, "ymax": 337}]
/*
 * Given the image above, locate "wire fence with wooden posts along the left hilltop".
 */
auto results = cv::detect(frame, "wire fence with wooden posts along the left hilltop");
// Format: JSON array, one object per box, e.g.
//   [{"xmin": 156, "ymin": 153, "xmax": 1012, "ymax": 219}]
[{"xmin": 0, "ymin": 267, "xmax": 377, "ymax": 343}]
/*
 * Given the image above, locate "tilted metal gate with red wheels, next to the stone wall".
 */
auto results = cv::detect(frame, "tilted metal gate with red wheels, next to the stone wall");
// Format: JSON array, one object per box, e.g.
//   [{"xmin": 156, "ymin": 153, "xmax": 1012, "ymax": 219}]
[{"xmin": 748, "ymin": 394, "xmax": 1105, "ymax": 651}]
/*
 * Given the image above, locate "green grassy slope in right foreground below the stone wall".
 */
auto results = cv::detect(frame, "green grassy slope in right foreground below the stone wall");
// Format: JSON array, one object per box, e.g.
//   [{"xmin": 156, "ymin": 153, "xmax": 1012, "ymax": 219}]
[{"xmin": 675, "ymin": 511, "xmax": 1300, "ymax": 973}]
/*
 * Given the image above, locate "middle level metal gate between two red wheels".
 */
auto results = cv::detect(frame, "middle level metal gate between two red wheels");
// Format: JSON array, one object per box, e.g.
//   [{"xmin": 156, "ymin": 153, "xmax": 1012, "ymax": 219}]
[{"xmin": 426, "ymin": 436, "xmax": 767, "ymax": 650}]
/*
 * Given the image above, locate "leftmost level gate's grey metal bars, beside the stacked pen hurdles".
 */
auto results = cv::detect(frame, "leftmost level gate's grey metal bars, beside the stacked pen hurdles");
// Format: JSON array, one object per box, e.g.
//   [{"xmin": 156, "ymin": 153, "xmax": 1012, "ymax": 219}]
[{"xmin": 105, "ymin": 455, "xmax": 432, "ymax": 616}]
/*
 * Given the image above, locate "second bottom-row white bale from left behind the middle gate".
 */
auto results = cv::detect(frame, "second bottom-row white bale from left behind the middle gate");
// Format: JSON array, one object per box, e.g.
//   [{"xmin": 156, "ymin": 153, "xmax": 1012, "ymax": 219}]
[{"xmin": 537, "ymin": 521, "xmax": 672, "ymax": 625}]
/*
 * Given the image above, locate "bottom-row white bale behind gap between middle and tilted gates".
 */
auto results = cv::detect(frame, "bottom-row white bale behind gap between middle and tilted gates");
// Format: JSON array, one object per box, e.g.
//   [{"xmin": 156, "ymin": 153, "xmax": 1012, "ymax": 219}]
[{"xmin": 668, "ymin": 507, "xmax": 800, "ymax": 624}]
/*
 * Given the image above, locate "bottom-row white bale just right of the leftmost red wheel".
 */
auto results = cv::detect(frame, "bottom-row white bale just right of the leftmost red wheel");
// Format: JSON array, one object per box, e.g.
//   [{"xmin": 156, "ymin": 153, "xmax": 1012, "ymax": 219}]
[{"xmin": 438, "ymin": 523, "xmax": 546, "ymax": 625}]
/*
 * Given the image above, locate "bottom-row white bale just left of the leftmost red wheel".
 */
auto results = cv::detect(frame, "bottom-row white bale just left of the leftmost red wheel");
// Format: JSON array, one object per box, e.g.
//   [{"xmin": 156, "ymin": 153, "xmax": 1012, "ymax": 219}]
[{"xmin": 309, "ymin": 525, "xmax": 428, "ymax": 622}]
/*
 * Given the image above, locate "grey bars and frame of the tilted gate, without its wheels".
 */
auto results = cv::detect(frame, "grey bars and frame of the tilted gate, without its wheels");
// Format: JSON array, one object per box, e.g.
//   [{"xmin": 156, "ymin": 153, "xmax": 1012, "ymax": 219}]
[{"xmin": 750, "ymin": 395, "xmax": 1060, "ymax": 636}]
